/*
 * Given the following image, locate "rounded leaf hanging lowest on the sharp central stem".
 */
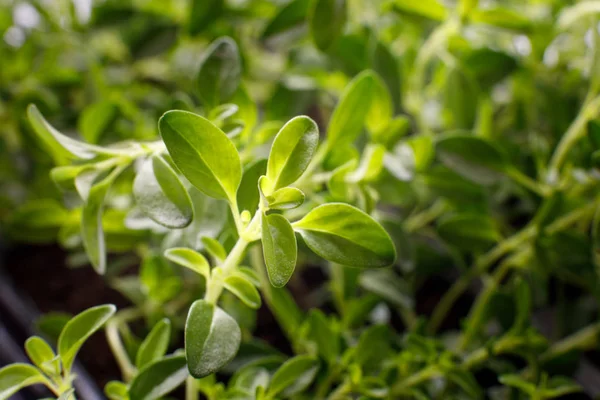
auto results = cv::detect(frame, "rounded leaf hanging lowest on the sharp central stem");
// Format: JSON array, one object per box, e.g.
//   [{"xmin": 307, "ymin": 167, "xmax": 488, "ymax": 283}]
[{"xmin": 185, "ymin": 300, "xmax": 242, "ymax": 378}]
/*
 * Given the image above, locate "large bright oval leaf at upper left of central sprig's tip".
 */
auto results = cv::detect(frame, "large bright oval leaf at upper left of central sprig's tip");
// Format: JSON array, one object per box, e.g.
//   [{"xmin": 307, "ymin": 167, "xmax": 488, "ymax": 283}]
[{"xmin": 158, "ymin": 111, "xmax": 242, "ymax": 201}]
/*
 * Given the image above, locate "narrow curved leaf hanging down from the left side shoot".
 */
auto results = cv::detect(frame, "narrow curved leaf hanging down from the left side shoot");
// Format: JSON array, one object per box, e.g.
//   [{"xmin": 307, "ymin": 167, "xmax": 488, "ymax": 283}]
[{"xmin": 81, "ymin": 167, "xmax": 124, "ymax": 274}]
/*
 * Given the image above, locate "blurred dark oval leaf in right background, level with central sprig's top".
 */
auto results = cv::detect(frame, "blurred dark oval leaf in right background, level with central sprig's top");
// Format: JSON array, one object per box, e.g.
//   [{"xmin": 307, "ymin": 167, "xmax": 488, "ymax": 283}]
[{"xmin": 436, "ymin": 134, "xmax": 507, "ymax": 185}]
